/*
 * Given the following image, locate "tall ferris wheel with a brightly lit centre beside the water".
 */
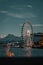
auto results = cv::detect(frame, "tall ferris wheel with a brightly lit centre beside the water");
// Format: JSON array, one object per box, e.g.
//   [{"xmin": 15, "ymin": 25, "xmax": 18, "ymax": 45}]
[{"xmin": 21, "ymin": 21, "xmax": 33, "ymax": 47}]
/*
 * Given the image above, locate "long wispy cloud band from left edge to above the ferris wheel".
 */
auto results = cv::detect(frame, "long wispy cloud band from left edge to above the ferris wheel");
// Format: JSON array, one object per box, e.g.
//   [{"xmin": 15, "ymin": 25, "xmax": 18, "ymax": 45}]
[{"xmin": 0, "ymin": 11, "xmax": 37, "ymax": 19}]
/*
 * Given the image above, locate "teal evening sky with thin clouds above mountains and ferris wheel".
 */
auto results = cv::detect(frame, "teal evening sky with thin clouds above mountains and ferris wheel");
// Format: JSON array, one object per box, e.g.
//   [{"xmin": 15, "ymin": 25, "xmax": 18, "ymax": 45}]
[{"xmin": 0, "ymin": 0, "xmax": 43, "ymax": 36}]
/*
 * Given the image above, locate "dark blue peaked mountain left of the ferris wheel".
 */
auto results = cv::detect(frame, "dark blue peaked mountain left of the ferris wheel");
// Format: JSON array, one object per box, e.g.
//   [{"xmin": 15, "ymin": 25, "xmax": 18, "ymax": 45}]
[{"xmin": 0, "ymin": 34, "xmax": 21, "ymax": 43}]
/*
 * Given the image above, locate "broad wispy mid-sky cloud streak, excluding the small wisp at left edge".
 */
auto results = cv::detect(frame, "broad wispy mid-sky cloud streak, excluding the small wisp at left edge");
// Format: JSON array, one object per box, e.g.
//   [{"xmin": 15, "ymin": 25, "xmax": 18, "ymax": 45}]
[{"xmin": 7, "ymin": 12, "xmax": 36, "ymax": 19}]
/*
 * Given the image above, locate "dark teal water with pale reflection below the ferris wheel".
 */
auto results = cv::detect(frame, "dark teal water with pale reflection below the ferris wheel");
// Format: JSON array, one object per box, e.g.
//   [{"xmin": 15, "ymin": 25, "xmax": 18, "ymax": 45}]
[{"xmin": 0, "ymin": 48, "xmax": 43, "ymax": 57}]
